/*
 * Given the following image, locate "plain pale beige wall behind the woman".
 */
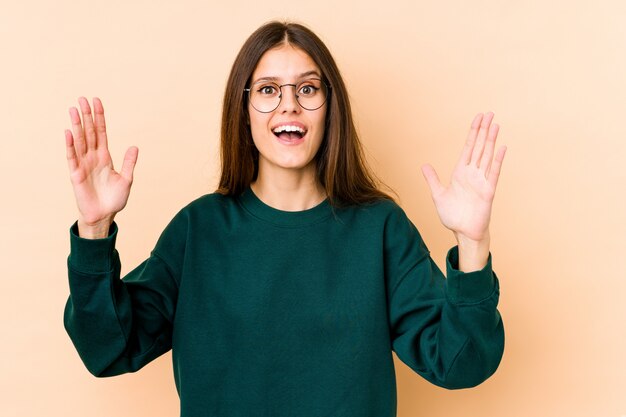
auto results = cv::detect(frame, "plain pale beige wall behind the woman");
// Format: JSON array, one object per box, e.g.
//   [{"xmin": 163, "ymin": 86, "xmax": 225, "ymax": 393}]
[{"xmin": 0, "ymin": 0, "xmax": 626, "ymax": 417}]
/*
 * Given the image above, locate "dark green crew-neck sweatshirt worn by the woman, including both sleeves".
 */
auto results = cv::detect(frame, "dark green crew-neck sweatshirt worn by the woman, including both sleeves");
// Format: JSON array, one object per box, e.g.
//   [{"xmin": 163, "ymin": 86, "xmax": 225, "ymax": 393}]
[{"xmin": 64, "ymin": 189, "xmax": 504, "ymax": 417}]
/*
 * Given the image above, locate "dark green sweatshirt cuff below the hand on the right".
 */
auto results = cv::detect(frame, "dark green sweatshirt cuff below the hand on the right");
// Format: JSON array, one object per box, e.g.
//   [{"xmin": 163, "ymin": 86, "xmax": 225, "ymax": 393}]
[{"xmin": 446, "ymin": 246, "xmax": 497, "ymax": 304}]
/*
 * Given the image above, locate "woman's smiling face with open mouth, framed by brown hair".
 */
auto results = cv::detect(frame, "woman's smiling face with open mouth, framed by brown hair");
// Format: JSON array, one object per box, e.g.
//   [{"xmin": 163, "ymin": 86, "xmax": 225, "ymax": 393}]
[{"xmin": 248, "ymin": 44, "xmax": 327, "ymax": 175}]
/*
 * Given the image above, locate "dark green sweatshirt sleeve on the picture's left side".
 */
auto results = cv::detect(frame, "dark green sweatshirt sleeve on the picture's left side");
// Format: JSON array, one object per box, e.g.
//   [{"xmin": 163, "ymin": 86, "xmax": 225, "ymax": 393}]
[{"xmin": 64, "ymin": 214, "xmax": 181, "ymax": 377}]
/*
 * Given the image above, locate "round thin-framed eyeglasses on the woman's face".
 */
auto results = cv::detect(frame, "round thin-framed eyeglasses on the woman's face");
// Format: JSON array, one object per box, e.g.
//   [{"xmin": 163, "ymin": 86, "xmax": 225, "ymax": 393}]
[{"xmin": 243, "ymin": 78, "xmax": 330, "ymax": 113}]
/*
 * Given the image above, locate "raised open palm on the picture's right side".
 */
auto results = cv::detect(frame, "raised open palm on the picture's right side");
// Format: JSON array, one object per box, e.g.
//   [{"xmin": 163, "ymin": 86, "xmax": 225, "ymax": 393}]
[{"xmin": 422, "ymin": 113, "xmax": 506, "ymax": 246}]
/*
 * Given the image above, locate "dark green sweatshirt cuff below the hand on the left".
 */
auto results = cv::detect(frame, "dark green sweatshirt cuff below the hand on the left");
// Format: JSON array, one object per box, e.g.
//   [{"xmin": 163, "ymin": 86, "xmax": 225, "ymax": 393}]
[{"xmin": 68, "ymin": 222, "xmax": 117, "ymax": 273}]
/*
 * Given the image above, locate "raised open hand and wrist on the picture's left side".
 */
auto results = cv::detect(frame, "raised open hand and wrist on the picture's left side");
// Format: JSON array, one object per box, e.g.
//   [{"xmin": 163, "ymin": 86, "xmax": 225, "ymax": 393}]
[{"xmin": 65, "ymin": 97, "xmax": 139, "ymax": 239}]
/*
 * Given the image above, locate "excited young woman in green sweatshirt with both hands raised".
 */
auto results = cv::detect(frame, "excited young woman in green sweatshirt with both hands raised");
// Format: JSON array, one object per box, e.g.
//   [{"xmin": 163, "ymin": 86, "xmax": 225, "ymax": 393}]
[{"xmin": 65, "ymin": 22, "xmax": 504, "ymax": 417}]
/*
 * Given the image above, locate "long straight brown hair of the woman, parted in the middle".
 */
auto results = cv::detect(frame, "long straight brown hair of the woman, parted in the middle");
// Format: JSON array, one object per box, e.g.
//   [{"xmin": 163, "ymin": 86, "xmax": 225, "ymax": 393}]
[{"xmin": 217, "ymin": 22, "xmax": 392, "ymax": 205}]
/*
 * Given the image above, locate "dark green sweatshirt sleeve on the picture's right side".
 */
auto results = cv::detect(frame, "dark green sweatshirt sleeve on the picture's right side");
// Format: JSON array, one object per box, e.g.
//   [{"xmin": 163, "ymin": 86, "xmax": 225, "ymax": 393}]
[{"xmin": 384, "ymin": 206, "xmax": 504, "ymax": 389}]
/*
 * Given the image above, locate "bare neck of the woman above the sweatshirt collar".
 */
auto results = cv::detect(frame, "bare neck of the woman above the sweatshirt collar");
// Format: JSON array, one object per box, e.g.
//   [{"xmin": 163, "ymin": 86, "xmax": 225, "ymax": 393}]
[{"xmin": 250, "ymin": 170, "xmax": 326, "ymax": 211}]
